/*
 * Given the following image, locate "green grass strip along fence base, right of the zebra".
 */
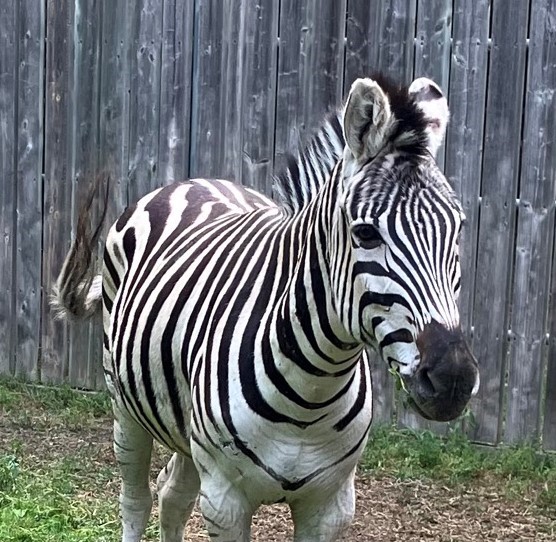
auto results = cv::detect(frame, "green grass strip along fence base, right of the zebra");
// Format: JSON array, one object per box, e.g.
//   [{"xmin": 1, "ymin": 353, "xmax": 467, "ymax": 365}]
[{"xmin": 360, "ymin": 426, "xmax": 556, "ymax": 511}]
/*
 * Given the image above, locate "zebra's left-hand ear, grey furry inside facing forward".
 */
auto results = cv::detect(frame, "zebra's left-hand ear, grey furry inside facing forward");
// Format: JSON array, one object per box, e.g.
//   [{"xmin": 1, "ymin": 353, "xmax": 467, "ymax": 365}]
[{"xmin": 344, "ymin": 79, "xmax": 394, "ymax": 160}]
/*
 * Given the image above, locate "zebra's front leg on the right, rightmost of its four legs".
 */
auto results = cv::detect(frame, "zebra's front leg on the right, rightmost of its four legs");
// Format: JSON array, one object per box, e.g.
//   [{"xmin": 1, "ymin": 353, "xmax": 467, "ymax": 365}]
[{"xmin": 291, "ymin": 471, "xmax": 355, "ymax": 542}]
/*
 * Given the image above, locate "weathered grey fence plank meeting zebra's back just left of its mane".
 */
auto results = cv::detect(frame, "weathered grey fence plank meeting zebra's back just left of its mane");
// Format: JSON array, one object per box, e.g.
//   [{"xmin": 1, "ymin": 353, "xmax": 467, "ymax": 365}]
[{"xmin": 239, "ymin": 1, "xmax": 280, "ymax": 195}]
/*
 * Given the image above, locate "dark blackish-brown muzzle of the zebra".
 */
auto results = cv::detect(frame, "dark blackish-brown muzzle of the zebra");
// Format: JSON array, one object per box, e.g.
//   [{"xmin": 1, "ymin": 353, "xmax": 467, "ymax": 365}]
[{"xmin": 405, "ymin": 322, "xmax": 479, "ymax": 421}]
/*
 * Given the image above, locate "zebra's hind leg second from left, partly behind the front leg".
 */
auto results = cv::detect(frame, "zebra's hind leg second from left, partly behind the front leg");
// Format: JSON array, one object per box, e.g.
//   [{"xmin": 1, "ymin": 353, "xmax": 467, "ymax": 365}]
[{"xmin": 156, "ymin": 453, "xmax": 200, "ymax": 542}]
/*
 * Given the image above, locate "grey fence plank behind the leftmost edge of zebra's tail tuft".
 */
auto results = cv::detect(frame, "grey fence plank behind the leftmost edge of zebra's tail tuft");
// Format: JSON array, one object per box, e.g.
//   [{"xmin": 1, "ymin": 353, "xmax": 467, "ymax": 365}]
[{"xmin": 40, "ymin": 0, "xmax": 75, "ymax": 383}]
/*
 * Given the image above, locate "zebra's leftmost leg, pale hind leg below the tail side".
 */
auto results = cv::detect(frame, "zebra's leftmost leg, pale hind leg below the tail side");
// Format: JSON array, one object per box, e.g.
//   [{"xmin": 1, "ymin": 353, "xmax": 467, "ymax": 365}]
[{"xmin": 114, "ymin": 408, "xmax": 153, "ymax": 542}]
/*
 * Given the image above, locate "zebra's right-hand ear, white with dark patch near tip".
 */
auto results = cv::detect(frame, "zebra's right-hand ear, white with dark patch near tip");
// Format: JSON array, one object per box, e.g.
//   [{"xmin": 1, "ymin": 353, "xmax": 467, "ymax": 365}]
[{"xmin": 409, "ymin": 77, "xmax": 450, "ymax": 156}]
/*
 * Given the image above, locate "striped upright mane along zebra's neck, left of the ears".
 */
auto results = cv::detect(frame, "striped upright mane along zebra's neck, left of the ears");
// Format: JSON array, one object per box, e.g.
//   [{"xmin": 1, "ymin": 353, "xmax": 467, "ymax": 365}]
[{"xmin": 273, "ymin": 110, "xmax": 345, "ymax": 214}]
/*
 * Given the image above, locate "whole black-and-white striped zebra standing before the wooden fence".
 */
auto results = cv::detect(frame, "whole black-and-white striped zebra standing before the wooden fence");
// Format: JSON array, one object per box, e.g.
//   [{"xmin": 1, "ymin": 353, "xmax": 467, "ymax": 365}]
[{"xmin": 53, "ymin": 77, "xmax": 479, "ymax": 542}]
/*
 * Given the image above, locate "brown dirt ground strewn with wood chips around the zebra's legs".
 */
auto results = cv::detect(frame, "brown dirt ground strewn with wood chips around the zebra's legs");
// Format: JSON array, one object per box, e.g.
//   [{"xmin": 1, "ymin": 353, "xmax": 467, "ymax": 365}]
[{"xmin": 0, "ymin": 416, "xmax": 556, "ymax": 542}]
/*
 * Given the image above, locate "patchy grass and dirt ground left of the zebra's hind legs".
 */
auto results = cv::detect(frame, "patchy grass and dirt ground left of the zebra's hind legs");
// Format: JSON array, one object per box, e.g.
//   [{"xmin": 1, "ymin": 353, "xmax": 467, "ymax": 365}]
[{"xmin": 0, "ymin": 380, "xmax": 158, "ymax": 542}]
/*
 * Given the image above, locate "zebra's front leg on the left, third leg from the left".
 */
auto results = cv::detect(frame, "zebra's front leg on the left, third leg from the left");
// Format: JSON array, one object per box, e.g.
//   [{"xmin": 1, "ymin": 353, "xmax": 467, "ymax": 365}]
[{"xmin": 199, "ymin": 474, "xmax": 254, "ymax": 542}]
